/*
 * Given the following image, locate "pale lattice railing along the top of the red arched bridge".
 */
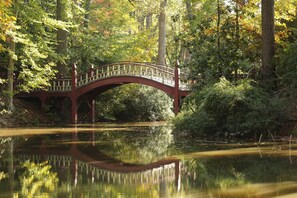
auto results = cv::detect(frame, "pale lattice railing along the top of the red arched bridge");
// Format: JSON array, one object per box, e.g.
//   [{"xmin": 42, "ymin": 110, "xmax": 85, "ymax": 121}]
[{"xmin": 30, "ymin": 62, "xmax": 190, "ymax": 92}]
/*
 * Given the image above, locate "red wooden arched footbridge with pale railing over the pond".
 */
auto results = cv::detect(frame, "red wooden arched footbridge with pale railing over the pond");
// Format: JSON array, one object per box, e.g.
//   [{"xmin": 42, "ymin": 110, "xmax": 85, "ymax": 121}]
[{"xmin": 16, "ymin": 62, "xmax": 190, "ymax": 124}]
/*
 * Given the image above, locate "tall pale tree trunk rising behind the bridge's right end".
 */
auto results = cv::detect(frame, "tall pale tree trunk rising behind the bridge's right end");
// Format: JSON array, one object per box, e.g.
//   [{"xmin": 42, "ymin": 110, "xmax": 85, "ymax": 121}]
[{"xmin": 157, "ymin": 0, "xmax": 167, "ymax": 65}]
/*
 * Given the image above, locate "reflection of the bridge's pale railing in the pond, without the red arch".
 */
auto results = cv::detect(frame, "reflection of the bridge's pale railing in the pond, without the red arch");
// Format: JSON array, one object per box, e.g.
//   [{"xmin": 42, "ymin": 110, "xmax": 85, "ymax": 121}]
[{"xmin": 16, "ymin": 154, "xmax": 180, "ymax": 185}]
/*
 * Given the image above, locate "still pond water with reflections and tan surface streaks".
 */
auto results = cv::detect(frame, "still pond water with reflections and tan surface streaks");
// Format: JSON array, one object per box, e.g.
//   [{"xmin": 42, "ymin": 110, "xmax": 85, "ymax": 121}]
[{"xmin": 0, "ymin": 123, "xmax": 297, "ymax": 198}]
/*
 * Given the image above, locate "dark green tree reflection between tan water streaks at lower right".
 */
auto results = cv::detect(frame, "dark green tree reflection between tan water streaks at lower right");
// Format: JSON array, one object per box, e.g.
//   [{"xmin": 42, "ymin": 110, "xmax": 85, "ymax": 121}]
[{"xmin": 180, "ymin": 156, "xmax": 297, "ymax": 192}]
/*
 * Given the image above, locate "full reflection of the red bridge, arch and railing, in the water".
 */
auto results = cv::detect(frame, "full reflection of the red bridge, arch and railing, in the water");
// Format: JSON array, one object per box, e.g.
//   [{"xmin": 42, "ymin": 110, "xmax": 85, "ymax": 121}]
[{"xmin": 15, "ymin": 134, "xmax": 180, "ymax": 186}]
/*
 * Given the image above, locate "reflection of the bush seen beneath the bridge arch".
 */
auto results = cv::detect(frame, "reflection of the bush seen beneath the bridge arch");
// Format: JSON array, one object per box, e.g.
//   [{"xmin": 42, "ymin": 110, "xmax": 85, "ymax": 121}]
[{"xmin": 96, "ymin": 126, "xmax": 172, "ymax": 164}]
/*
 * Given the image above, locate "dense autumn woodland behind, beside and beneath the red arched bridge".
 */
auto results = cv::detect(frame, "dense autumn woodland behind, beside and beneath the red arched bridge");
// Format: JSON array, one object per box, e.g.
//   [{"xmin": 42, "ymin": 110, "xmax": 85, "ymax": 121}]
[{"xmin": 0, "ymin": 0, "xmax": 297, "ymax": 137}]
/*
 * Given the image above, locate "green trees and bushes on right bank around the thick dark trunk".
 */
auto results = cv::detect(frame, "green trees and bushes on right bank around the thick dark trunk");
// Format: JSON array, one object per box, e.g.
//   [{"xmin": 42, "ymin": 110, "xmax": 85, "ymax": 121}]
[{"xmin": 174, "ymin": 0, "xmax": 297, "ymax": 136}]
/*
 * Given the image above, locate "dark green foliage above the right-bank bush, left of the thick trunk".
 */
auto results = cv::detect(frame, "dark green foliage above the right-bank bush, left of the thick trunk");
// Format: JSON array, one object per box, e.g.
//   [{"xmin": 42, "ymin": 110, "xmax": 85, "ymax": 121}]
[{"xmin": 181, "ymin": 1, "xmax": 261, "ymax": 88}]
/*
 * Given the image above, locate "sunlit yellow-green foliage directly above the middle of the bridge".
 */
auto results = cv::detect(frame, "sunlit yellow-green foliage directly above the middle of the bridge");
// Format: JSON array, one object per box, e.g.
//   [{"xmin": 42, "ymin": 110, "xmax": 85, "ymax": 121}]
[{"xmin": 69, "ymin": 0, "xmax": 157, "ymax": 71}]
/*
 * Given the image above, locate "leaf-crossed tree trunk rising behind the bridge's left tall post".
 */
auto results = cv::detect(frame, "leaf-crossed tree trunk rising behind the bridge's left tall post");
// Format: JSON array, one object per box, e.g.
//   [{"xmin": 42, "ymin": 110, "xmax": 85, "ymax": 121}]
[{"xmin": 56, "ymin": 0, "xmax": 68, "ymax": 77}]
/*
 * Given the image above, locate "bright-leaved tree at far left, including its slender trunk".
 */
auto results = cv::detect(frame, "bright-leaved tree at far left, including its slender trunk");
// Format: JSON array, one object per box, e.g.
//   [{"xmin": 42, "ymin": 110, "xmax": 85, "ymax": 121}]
[{"xmin": 0, "ymin": 0, "xmax": 73, "ymax": 110}]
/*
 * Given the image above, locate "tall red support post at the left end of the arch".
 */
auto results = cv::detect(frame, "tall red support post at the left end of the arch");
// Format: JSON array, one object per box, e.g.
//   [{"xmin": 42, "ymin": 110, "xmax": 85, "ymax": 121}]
[{"xmin": 70, "ymin": 64, "xmax": 77, "ymax": 124}]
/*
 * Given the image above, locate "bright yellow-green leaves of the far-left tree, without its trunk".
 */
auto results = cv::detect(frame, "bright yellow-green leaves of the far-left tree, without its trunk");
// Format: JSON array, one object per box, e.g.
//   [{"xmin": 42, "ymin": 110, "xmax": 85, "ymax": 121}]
[{"xmin": 3, "ymin": 0, "xmax": 73, "ymax": 92}]
